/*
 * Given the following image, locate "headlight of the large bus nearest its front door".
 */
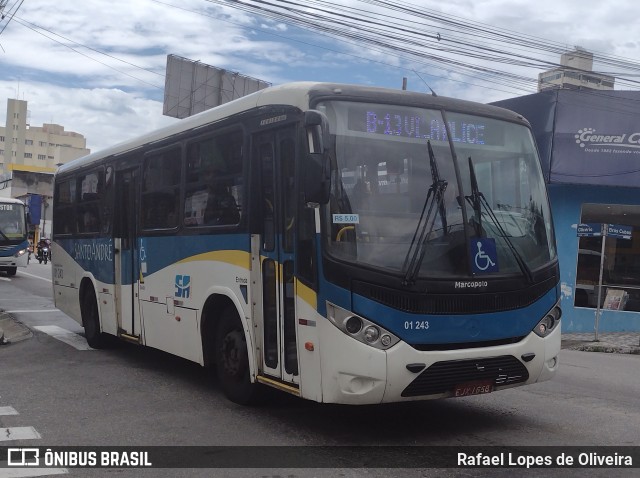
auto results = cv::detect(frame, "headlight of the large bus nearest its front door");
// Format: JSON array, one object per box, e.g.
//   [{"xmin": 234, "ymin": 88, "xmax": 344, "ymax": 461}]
[{"xmin": 327, "ymin": 302, "xmax": 400, "ymax": 350}]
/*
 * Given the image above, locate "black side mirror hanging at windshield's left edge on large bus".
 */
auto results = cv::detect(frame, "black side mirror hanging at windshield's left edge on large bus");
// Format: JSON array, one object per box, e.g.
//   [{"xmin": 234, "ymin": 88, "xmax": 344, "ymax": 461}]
[{"xmin": 302, "ymin": 110, "xmax": 333, "ymax": 204}]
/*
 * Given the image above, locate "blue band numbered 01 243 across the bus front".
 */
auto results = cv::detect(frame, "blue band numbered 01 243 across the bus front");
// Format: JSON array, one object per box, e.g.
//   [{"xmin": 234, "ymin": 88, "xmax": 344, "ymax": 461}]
[{"xmin": 353, "ymin": 288, "xmax": 557, "ymax": 344}]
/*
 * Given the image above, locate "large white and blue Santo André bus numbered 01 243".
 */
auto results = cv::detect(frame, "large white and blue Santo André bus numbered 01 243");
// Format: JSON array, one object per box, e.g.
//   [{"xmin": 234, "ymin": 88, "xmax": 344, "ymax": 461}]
[{"xmin": 52, "ymin": 83, "xmax": 561, "ymax": 404}]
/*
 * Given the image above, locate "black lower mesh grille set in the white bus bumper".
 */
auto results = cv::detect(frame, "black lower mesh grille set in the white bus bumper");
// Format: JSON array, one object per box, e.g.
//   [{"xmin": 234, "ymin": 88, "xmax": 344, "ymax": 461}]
[{"xmin": 402, "ymin": 355, "xmax": 529, "ymax": 397}]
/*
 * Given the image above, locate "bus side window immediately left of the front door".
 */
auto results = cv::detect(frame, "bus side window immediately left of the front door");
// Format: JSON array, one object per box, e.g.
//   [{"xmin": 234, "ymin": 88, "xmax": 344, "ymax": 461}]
[{"xmin": 184, "ymin": 131, "xmax": 243, "ymax": 226}]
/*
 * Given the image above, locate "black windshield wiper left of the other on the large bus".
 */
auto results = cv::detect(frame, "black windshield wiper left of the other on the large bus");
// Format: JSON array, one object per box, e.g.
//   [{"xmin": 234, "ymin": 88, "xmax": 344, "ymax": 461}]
[{"xmin": 402, "ymin": 141, "xmax": 448, "ymax": 286}]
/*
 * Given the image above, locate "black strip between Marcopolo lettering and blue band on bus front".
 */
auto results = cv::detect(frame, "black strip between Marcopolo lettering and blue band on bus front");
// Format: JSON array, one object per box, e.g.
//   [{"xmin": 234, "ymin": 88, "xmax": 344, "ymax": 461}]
[{"xmin": 353, "ymin": 278, "xmax": 556, "ymax": 315}]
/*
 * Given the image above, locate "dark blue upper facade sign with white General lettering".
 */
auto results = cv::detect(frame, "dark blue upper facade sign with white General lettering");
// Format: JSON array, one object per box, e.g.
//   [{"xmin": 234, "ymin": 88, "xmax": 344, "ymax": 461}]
[{"xmin": 494, "ymin": 90, "xmax": 640, "ymax": 187}]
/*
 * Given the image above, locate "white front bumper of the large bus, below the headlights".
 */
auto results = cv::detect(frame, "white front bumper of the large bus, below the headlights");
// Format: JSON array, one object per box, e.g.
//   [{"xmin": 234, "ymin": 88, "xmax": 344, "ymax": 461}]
[{"xmin": 319, "ymin": 320, "xmax": 561, "ymax": 404}]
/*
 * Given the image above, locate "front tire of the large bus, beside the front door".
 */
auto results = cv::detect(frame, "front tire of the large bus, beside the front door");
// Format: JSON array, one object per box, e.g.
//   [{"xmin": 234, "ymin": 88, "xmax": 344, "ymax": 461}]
[{"xmin": 215, "ymin": 307, "xmax": 261, "ymax": 405}]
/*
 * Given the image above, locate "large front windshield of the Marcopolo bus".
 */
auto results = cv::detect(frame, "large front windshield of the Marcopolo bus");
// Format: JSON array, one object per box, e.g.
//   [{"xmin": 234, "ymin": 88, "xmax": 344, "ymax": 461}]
[{"xmin": 319, "ymin": 101, "xmax": 556, "ymax": 279}]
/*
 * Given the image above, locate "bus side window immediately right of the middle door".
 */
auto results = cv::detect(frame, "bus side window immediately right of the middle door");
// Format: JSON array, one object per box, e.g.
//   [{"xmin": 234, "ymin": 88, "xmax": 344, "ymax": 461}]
[{"xmin": 142, "ymin": 147, "xmax": 182, "ymax": 229}]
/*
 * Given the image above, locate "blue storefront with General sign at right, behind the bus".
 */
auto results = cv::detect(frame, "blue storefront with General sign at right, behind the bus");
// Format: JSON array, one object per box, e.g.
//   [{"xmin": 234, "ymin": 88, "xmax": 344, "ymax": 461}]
[{"xmin": 494, "ymin": 90, "xmax": 640, "ymax": 332}]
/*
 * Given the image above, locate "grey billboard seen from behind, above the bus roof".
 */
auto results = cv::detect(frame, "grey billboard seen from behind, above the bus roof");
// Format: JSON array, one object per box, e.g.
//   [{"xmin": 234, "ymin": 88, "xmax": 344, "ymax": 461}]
[{"xmin": 162, "ymin": 55, "xmax": 271, "ymax": 118}]
